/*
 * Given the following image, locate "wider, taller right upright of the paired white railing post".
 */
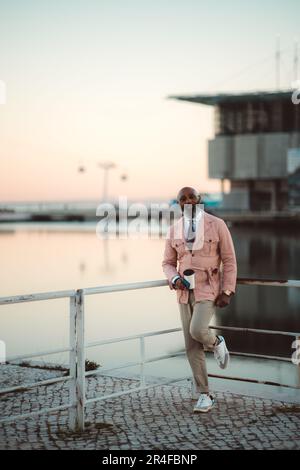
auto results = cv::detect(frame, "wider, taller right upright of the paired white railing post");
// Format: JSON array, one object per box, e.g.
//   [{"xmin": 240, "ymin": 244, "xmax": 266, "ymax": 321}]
[{"xmin": 75, "ymin": 289, "xmax": 85, "ymax": 431}]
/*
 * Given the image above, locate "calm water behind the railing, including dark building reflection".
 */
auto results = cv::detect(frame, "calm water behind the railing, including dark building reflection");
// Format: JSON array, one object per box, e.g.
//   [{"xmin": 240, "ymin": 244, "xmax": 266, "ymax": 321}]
[{"xmin": 0, "ymin": 223, "xmax": 300, "ymax": 388}]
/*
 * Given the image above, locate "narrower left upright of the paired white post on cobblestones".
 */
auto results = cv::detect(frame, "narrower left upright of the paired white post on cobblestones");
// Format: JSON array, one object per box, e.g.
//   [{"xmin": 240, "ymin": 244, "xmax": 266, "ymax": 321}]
[{"xmin": 69, "ymin": 295, "xmax": 77, "ymax": 431}]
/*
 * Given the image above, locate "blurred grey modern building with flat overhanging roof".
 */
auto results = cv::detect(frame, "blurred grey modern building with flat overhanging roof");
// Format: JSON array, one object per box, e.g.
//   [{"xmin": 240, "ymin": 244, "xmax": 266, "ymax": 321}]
[{"xmin": 169, "ymin": 90, "xmax": 300, "ymax": 211}]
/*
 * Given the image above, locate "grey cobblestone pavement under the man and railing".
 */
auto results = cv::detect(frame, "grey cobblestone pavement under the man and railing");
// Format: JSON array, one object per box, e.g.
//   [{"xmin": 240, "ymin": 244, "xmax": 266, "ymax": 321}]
[{"xmin": 0, "ymin": 366, "xmax": 300, "ymax": 450}]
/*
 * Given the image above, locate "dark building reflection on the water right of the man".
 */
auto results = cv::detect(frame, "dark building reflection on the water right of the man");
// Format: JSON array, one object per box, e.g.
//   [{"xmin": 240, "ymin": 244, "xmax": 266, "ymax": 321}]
[{"xmin": 217, "ymin": 227, "xmax": 300, "ymax": 357}]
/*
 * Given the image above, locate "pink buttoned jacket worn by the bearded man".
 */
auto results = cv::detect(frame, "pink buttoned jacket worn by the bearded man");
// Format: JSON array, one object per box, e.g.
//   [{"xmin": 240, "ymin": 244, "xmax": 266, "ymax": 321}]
[{"xmin": 162, "ymin": 212, "xmax": 237, "ymax": 304}]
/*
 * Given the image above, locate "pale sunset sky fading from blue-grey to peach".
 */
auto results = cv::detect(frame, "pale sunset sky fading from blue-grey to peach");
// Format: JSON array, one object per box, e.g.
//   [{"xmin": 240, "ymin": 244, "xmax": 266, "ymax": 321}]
[{"xmin": 0, "ymin": 0, "xmax": 300, "ymax": 202}]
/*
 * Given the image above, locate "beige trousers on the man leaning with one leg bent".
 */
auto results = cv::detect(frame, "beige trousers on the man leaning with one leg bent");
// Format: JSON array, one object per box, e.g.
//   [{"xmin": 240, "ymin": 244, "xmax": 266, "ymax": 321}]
[{"xmin": 178, "ymin": 290, "xmax": 216, "ymax": 393}]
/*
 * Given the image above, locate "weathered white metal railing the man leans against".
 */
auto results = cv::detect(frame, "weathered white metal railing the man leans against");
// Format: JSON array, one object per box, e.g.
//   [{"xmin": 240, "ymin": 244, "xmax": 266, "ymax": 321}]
[{"xmin": 0, "ymin": 278, "xmax": 300, "ymax": 430}]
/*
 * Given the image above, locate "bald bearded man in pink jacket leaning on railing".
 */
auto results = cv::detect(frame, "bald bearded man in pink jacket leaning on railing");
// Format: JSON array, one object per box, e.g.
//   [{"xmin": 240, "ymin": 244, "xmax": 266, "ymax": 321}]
[{"xmin": 162, "ymin": 187, "xmax": 237, "ymax": 412}]
